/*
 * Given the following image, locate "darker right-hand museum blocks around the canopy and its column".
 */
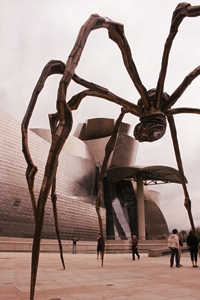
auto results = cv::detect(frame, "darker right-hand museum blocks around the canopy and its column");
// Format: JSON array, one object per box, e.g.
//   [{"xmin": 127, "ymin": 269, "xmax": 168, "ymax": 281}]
[{"xmin": 75, "ymin": 119, "xmax": 169, "ymax": 239}]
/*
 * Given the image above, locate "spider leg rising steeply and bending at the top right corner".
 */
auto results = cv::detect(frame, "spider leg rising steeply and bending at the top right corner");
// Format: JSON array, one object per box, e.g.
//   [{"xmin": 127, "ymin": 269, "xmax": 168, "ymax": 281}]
[{"xmin": 154, "ymin": 2, "xmax": 200, "ymax": 109}]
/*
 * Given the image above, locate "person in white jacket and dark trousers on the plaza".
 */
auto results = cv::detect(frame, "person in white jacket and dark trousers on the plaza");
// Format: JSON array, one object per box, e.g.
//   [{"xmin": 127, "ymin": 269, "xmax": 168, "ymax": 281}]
[{"xmin": 168, "ymin": 229, "xmax": 180, "ymax": 268}]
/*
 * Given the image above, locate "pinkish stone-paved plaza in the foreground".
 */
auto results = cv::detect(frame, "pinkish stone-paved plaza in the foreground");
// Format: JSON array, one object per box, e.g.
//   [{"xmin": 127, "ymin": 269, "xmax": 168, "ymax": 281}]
[{"xmin": 0, "ymin": 252, "xmax": 200, "ymax": 300}]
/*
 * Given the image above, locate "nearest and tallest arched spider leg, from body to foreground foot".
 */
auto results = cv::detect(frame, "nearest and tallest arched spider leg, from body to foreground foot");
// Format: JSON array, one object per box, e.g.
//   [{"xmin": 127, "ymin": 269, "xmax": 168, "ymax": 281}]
[{"xmin": 27, "ymin": 11, "xmax": 149, "ymax": 300}]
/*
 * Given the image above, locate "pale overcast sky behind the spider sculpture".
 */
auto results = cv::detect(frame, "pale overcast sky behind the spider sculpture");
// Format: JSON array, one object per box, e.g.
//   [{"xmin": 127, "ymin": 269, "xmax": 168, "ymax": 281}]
[{"xmin": 0, "ymin": 0, "xmax": 200, "ymax": 230}]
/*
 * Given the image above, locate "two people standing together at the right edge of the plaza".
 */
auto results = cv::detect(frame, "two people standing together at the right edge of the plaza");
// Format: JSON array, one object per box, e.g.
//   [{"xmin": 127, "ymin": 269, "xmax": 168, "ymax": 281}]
[{"xmin": 168, "ymin": 229, "xmax": 199, "ymax": 268}]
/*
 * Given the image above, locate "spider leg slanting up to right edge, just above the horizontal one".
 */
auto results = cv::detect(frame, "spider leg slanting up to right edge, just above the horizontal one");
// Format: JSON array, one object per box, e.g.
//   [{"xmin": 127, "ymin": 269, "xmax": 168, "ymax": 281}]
[{"xmin": 161, "ymin": 66, "xmax": 200, "ymax": 111}]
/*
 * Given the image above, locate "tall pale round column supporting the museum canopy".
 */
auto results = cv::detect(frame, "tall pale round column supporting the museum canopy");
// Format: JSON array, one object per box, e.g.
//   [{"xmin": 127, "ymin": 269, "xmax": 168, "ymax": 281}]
[{"xmin": 137, "ymin": 174, "xmax": 145, "ymax": 240}]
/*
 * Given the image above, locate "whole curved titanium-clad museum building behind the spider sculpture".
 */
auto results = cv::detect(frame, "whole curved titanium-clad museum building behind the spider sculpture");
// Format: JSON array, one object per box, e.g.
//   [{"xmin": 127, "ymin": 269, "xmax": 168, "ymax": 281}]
[{"xmin": 0, "ymin": 111, "xmax": 168, "ymax": 240}]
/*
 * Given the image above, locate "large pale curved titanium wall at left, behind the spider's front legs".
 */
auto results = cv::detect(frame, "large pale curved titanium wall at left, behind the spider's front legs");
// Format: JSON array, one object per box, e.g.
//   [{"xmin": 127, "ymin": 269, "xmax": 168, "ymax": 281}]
[{"xmin": 0, "ymin": 111, "xmax": 105, "ymax": 240}]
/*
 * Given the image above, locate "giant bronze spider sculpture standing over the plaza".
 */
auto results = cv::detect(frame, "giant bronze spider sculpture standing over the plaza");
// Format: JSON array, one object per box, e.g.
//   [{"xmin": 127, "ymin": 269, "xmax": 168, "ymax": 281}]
[{"xmin": 22, "ymin": 3, "xmax": 200, "ymax": 300}]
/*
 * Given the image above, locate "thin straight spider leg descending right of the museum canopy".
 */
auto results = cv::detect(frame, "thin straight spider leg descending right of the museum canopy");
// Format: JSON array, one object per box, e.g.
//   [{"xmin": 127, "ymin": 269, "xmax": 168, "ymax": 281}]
[{"xmin": 167, "ymin": 116, "xmax": 195, "ymax": 232}]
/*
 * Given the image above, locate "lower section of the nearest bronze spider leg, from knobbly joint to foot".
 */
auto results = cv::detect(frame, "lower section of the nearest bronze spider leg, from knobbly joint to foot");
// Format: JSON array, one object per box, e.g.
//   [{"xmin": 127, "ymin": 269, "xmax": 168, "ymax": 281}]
[{"xmin": 30, "ymin": 101, "xmax": 72, "ymax": 300}]
